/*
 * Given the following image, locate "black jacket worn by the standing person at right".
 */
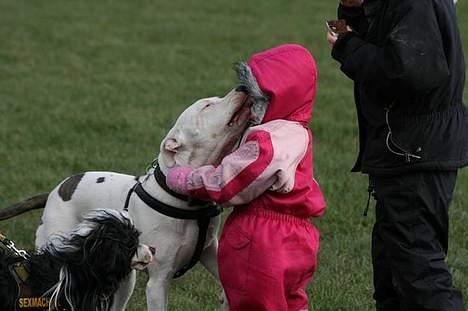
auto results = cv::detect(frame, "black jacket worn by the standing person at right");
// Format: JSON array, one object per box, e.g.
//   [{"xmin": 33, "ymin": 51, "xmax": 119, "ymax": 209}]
[{"xmin": 332, "ymin": 0, "xmax": 468, "ymax": 175}]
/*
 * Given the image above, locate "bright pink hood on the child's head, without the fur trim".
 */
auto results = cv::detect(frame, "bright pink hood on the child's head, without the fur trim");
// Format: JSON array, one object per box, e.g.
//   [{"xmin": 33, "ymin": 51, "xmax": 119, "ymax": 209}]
[{"xmin": 248, "ymin": 44, "xmax": 317, "ymax": 125}]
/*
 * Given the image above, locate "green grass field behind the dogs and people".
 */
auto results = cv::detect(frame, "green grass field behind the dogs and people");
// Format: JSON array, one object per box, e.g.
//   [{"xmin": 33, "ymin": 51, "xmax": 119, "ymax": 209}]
[{"xmin": 0, "ymin": 0, "xmax": 468, "ymax": 311}]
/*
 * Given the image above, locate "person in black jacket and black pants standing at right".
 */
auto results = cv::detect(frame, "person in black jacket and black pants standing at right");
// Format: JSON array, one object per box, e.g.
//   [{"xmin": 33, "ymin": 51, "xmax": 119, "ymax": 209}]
[{"xmin": 327, "ymin": 0, "xmax": 468, "ymax": 311}]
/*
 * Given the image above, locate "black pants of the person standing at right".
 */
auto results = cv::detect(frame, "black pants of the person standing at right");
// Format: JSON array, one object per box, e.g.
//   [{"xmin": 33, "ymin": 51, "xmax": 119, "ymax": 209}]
[{"xmin": 371, "ymin": 171, "xmax": 464, "ymax": 311}]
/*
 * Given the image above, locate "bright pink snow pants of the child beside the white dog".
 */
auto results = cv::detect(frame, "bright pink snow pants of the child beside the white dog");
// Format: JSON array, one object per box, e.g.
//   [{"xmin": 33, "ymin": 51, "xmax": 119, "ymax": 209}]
[{"xmin": 218, "ymin": 207, "xmax": 319, "ymax": 311}]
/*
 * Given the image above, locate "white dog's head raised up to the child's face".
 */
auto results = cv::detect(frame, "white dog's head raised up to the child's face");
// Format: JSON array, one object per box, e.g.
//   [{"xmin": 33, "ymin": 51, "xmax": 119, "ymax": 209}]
[{"xmin": 159, "ymin": 88, "xmax": 252, "ymax": 168}]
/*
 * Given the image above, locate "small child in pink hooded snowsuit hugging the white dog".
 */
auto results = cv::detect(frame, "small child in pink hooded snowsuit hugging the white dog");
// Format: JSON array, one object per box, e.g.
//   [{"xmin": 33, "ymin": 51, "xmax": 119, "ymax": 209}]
[{"xmin": 167, "ymin": 44, "xmax": 325, "ymax": 311}]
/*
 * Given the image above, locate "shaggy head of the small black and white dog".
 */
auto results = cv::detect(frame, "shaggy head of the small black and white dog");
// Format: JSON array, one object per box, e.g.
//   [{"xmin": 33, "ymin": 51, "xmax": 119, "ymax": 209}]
[{"xmin": 43, "ymin": 210, "xmax": 155, "ymax": 310}]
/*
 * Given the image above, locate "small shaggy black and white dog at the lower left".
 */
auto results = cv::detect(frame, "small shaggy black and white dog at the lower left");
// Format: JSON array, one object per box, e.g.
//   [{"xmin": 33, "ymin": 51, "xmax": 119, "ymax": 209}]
[{"xmin": 0, "ymin": 210, "xmax": 155, "ymax": 311}]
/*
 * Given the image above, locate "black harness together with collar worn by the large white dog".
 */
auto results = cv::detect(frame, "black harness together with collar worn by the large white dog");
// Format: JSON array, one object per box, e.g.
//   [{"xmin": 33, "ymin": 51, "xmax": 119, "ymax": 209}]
[{"xmin": 124, "ymin": 164, "xmax": 221, "ymax": 278}]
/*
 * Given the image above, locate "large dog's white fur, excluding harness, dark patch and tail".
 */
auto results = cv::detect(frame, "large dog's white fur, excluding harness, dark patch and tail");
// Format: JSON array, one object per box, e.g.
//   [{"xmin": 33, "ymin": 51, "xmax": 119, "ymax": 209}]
[{"xmin": 36, "ymin": 90, "xmax": 250, "ymax": 311}]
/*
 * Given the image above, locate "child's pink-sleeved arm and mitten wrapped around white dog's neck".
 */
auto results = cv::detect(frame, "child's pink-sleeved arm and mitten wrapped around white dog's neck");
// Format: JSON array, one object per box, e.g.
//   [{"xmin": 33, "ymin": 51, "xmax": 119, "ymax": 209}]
[{"xmin": 167, "ymin": 131, "xmax": 279, "ymax": 205}]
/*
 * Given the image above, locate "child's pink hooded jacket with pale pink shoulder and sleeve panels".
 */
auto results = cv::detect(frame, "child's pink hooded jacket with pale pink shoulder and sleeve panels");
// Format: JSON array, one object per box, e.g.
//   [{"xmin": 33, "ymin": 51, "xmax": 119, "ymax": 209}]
[{"xmin": 167, "ymin": 44, "xmax": 325, "ymax": 218}]
